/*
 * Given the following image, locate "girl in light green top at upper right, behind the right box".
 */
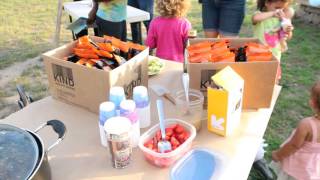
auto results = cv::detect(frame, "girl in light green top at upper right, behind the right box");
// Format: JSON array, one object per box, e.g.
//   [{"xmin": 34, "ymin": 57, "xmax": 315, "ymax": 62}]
[{"xmin": 252, "ymin": 0, "xmax": 294, "ymax": 80}]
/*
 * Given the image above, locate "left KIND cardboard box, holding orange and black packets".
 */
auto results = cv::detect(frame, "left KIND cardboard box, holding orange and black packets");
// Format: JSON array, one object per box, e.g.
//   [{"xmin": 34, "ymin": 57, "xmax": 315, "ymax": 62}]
[{"xmin": 42, "ymin": 37, "xmax": 149, "ymax": 113}]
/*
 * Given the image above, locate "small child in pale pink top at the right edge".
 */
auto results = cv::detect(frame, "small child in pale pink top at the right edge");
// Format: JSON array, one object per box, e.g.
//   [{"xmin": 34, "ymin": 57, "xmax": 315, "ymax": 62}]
[{"xmin": 271, "ymin": 81, "xmax": 320, "ymax": 180}]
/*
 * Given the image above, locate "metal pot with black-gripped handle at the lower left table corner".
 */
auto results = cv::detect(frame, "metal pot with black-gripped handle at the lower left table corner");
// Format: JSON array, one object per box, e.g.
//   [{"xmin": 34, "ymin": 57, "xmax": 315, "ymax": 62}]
[{"xmin": 0, "ymin": 120, "xmax": 66, "ymax": 180}]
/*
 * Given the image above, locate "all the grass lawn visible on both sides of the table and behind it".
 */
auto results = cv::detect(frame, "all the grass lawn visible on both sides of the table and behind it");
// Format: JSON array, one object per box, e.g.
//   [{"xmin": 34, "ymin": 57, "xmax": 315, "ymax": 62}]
[{"xmin": 0, "ymin": 0, "xmax": 320, "ymax": 179}]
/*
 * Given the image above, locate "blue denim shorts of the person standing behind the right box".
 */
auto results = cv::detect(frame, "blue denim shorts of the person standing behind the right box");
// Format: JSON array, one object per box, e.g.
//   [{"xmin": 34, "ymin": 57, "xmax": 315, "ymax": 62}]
[{"xmin": 202, "ymin": 0, "xmax": 246, "ymax": 36}]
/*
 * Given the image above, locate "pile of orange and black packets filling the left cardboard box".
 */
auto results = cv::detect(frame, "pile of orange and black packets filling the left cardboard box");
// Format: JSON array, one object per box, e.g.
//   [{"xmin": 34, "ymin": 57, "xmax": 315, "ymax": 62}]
[{"xmin": 65, "ymin": 36, "xmax": 146, "ymax": 70}]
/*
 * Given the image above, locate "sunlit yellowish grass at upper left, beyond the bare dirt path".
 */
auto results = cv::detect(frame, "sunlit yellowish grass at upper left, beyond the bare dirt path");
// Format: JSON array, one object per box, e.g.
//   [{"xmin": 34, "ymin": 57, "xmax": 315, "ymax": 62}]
[{"xmin": 0, "ymin": 0, "xmax": 71, "ymax": 69}]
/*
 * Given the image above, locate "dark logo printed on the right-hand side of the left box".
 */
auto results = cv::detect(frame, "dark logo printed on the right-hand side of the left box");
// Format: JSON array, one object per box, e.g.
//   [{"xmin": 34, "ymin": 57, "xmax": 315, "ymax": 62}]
[{"xmin": 123, "ymin": 65, "xmax": 142, "ymax": 98}]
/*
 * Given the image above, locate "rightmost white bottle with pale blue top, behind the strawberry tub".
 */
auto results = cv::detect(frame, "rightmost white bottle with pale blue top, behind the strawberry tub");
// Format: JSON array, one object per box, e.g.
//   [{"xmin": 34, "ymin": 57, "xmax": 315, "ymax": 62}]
[{"xmin": 133, "ymin": 86, "xmax": 151, "ymax": 128}]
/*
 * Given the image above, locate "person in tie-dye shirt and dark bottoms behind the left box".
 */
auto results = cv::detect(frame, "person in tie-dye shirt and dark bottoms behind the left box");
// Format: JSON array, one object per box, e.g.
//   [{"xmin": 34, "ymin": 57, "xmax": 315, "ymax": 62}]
[{"xmin": 88, "ymin": 0, "xmax": 127, "ymax": 41}]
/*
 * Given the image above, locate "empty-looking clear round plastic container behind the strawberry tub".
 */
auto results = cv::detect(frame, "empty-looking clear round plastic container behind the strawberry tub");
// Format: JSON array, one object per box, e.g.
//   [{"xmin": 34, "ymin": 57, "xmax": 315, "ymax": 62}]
[{"xmin": 174, "ymin": 89, "xmax": 204, "ymax": 132}]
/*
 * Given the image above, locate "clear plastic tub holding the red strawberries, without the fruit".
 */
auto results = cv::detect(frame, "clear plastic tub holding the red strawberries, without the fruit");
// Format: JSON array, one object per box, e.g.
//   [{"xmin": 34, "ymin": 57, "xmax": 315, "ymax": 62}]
[{"xmin": 139, "ymin": 119, "xmax": 197, "ymax": 167}]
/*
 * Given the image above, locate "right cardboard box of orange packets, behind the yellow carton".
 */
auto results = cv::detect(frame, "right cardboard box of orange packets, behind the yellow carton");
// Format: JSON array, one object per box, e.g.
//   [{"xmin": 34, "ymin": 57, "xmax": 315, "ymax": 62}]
[{"xmin": 188, "ymin": 38, "xmax": 279, "ymax": 109}]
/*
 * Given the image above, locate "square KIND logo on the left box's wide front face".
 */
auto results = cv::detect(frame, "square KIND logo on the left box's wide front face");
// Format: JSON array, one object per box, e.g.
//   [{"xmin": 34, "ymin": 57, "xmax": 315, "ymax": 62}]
[{"xmin": 52, "ymin": 64, "xmax": 75, "ymax": 90}]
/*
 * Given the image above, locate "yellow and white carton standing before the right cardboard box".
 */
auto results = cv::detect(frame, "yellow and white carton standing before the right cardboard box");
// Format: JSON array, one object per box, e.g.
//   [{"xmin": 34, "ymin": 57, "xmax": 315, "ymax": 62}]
[{"xmin": 208, "ymin": 66, "xmax": 244, "ymax": 136}]
